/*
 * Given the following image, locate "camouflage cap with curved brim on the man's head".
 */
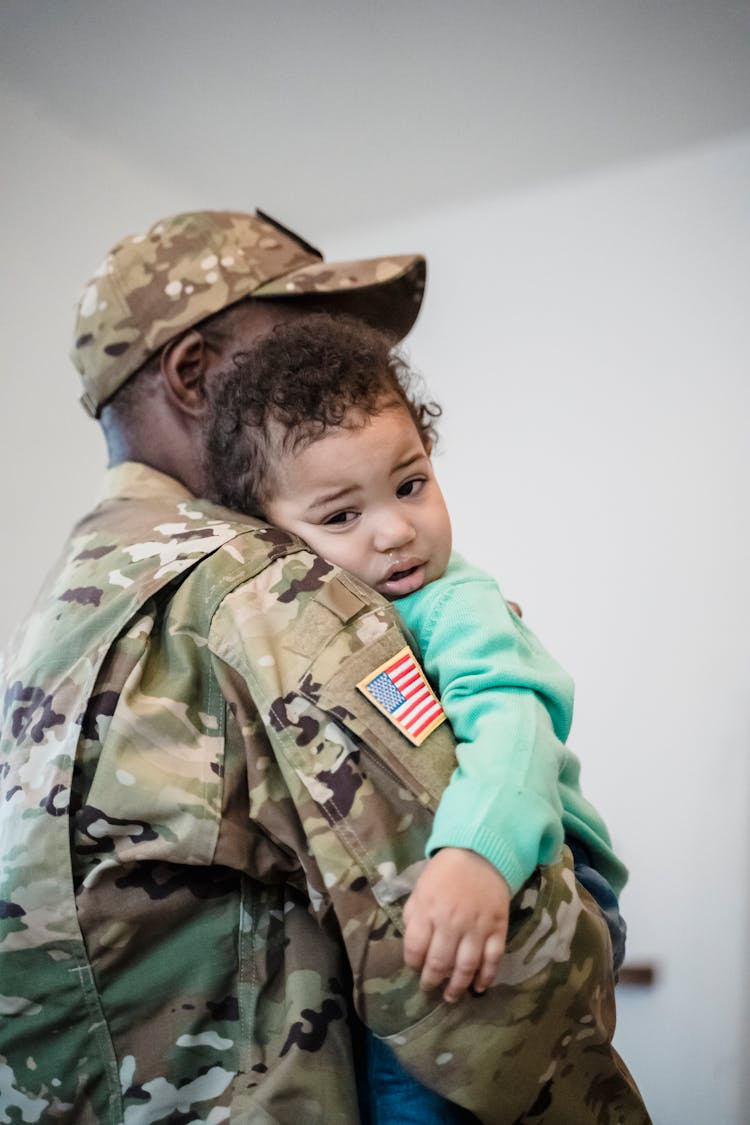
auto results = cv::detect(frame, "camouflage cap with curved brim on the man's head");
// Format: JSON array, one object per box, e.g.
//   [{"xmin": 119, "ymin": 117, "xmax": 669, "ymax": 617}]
[{"xmin": 71, "ymin": 210, "xmax": 426, "ymax": 417}]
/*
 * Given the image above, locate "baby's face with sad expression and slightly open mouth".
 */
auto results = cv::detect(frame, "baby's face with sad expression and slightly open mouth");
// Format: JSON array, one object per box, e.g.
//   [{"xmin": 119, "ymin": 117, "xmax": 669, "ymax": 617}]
[{"xmin": 264, "ymin": 405, "xmax": 451, "ymax": 599}]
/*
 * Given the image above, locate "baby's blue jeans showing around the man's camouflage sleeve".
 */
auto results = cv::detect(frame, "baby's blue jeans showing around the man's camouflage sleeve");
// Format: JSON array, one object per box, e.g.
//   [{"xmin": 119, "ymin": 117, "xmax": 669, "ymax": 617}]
[{"xmin": 367, "ymin": 837, "xmax": 627, "ymax": 1125}]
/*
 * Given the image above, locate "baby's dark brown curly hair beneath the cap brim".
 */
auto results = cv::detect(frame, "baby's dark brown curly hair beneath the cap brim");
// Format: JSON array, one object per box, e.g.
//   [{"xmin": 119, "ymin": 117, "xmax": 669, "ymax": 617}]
[{"xmin": 204, "ymin": 313, "xmax": 441, "ymax": 518}]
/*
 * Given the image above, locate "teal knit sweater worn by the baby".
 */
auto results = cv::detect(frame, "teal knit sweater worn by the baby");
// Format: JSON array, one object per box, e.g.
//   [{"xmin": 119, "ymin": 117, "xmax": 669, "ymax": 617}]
[{"xmin": 395, "ymin": 555, "xmax": 627, "ymax": 894}]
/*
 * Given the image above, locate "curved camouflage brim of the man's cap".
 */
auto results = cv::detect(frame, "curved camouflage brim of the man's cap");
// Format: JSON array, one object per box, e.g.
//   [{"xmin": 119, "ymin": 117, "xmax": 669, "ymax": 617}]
[{"xmin": 252, "ymin": 254, "xmax": 427, "ymax": 340}]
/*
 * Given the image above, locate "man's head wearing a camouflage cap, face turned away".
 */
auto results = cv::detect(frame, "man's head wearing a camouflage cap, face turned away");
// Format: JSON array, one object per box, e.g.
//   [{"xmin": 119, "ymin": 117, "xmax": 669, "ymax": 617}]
[{"xmin": 72, "ymin": 212, "xmax": 425, "ymax": 492}]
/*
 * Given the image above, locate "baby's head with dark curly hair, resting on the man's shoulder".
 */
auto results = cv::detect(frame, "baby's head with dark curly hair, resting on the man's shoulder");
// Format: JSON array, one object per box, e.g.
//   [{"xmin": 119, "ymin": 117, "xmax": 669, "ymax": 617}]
[{"xmin": 206, "ymin": 315, "xmax": 451, "ymax": 597}]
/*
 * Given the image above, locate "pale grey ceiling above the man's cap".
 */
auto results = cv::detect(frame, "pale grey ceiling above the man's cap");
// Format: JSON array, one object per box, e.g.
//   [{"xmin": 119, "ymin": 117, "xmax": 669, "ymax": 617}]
[{"xmin": 0, "ymin": 0, "xmax": 750, "ymax": 231}]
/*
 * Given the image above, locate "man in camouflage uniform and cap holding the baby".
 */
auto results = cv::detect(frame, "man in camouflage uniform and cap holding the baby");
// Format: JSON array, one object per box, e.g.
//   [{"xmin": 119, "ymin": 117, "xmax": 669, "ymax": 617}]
[{"xmin": 0, "ymin": 213, "xmax": 648, "ymax": 1125}]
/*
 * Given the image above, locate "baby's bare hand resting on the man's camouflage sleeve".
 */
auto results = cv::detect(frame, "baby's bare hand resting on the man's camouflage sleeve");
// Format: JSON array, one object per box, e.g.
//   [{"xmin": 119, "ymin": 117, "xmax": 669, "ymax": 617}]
[{"xmin": 404, "ymin": 847, "xmax": 510, "ymax": 1002}]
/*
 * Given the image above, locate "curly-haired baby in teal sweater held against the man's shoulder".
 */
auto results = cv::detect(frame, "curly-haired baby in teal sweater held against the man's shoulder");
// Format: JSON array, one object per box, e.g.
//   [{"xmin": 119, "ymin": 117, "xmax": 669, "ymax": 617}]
[{"xmin": 206, "ymin": 314, "xmax": 626, "ymax": 1122}]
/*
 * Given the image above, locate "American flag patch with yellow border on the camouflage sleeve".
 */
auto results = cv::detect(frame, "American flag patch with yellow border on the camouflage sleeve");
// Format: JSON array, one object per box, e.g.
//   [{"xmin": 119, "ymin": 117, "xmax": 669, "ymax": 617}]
[{"xmin": 356, "ymin": 647, "xmax": 445, "ymax": 746}]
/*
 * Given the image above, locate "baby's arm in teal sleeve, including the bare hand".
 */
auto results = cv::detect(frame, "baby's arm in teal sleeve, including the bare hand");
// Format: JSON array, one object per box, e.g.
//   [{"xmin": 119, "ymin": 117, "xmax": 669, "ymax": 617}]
[{"xmin": 397, "ymin": 559, "xmax": 572, "ymax": 999}]
